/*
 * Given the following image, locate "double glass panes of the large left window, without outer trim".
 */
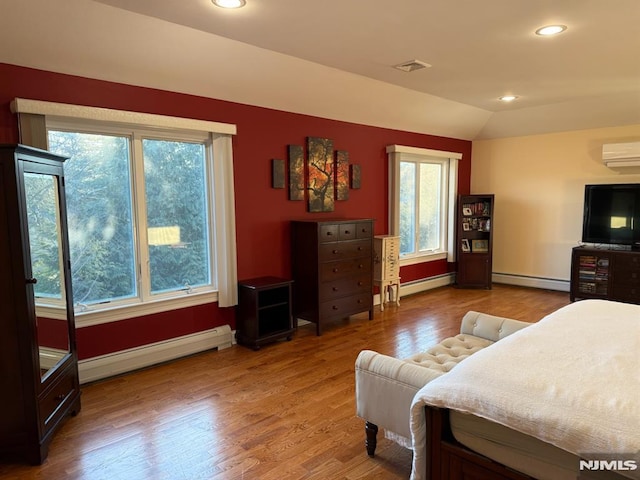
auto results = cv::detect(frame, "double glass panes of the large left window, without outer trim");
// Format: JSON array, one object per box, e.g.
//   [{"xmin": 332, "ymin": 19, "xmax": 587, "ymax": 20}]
[{"xmin": 48, "ymin": 122, "xmax": 215, "ymax": 311}]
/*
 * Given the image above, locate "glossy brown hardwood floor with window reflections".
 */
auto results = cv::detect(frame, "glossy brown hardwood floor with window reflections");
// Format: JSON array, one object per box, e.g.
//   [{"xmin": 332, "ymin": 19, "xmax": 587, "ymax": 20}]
[{"xmin": 0, "ymin": 285, "xmax": 569, "ymax": 480}]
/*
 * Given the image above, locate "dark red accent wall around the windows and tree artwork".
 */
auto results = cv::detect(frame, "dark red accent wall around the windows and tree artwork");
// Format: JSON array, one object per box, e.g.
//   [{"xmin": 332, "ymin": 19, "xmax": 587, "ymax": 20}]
[{"xmin": 0, "ymin": 63, "xmax": 471, "ymax": 359}]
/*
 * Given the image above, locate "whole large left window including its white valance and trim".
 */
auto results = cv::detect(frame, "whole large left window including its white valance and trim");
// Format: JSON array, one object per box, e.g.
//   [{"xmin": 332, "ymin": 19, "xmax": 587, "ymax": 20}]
[{"xmin": 11, "ymin": 99, "xmax": 237, "ymax": 326}]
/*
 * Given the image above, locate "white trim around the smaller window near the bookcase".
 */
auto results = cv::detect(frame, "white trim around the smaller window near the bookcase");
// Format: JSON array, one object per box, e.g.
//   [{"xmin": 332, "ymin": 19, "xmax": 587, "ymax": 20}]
[{"xmin": 387, "ymin": 145, "xmax": 462, "ymax": 266}]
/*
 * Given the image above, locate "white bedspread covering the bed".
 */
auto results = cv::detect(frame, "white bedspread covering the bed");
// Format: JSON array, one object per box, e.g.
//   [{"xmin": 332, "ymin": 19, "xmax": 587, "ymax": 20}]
[{"xmin": 411, "ymin": 300, "xmax": 640, "ymax": 480}]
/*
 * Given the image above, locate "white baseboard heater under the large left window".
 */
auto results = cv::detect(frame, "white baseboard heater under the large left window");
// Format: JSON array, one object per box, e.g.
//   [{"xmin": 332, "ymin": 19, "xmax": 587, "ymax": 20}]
[{"xmin": 78, "ymin": 325, "xmax": 232, "ymax": 384}]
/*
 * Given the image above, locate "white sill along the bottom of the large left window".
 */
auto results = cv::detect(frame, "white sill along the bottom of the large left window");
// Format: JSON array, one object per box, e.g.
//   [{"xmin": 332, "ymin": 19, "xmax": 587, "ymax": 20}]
[{"xmin": 36, "ymin": 292, "xmax": 218, "ymax": 328}]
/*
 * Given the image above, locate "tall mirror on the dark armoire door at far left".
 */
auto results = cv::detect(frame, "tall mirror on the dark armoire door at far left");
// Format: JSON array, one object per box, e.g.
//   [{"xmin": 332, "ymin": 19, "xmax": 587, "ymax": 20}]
[{"xmin": 24, "ymin": 172, "xmax": 70, "ymax": 381}]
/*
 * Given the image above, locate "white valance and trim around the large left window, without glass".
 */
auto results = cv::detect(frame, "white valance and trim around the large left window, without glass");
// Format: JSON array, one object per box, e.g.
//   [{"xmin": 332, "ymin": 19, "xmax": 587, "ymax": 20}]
[{"xmin": 11, "ymin": 98, "xmax": 238, "ymax": 328}]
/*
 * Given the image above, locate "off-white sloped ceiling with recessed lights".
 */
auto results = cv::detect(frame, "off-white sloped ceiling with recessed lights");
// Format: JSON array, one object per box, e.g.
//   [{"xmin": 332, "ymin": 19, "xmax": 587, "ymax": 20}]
[{"xmin": 0, "ymin": 0, "xmax": 640, "ymax": 139}]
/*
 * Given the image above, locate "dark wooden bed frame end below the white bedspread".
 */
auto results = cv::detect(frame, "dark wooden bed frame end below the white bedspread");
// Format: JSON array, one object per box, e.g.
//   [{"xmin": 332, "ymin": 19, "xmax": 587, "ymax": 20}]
[{"xmin": 425, "ymin": 407, "xmax": 534, "ymax": 480}]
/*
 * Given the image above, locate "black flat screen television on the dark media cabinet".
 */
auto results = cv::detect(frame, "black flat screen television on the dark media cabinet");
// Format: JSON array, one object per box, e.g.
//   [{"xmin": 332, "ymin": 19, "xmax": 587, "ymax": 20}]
[{"xmin": 582, "ymin": 183, "xmax": 640, "ymax": 249}]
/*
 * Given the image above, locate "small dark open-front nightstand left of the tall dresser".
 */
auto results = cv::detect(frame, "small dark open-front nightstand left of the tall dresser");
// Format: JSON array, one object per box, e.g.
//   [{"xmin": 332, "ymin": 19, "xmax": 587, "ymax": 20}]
[{"xmin": 236, "ymin": 277, "xmax": 295, "ymax": 350}]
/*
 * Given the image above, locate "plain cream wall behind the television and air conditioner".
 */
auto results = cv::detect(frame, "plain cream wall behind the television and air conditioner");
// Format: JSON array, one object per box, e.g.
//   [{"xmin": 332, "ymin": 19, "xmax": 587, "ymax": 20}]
[{"xmin": 471, "ymin": 125, "xmax": 640, "ymax": 289}]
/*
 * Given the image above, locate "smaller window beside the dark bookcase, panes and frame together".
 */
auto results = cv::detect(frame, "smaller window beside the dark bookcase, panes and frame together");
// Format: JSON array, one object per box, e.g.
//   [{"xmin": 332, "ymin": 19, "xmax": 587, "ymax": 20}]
[{"xmin": 387, "ymin": 145, "xmax": 461, "ymax": 264}]
